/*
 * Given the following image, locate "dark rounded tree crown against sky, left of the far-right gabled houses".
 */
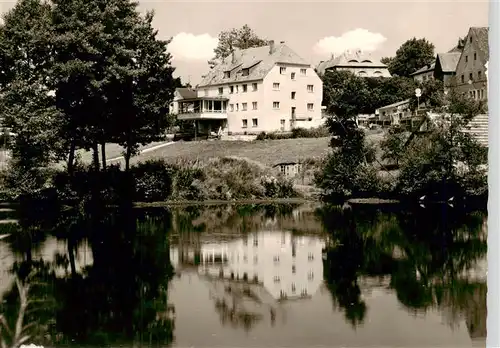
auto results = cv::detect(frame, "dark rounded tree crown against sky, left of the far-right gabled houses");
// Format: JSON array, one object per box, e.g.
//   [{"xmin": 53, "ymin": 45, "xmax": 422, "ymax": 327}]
[{"xmin": 381, "ymin": 38, "xmax": 435, "ymax": 77}]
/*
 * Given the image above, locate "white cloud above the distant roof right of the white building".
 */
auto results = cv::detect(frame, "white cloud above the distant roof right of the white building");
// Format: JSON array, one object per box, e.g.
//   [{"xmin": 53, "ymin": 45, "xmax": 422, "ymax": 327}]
[{"xmin": 314, "ymin": 28, "xmax": 387, "ymax": 55}]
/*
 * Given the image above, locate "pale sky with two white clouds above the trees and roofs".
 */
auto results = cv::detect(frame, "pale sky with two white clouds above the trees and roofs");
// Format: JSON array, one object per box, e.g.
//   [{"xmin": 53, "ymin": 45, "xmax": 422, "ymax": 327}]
[{"xmin": 0, "ymin": 0, "xmax": 488, "ymax": 84}]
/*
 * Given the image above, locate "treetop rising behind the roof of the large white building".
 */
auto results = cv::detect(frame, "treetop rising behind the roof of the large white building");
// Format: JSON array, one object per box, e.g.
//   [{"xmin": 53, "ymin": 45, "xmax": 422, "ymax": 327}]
[{"xmin": 210, "ymin": 24, "xmax": 269, "ymax": 59}]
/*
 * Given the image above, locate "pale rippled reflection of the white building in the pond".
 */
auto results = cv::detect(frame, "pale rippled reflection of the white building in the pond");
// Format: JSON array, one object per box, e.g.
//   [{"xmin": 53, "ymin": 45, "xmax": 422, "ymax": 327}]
[{"xmin": 171, "ymin": 231, "xmax": 324, "ymax": 299}]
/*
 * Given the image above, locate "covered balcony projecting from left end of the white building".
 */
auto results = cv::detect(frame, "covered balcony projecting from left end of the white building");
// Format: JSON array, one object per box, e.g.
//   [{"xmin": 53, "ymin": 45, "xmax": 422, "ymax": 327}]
[{"xmin": 177, "ymin": 97, "xmax": 228, "ymax": 120}]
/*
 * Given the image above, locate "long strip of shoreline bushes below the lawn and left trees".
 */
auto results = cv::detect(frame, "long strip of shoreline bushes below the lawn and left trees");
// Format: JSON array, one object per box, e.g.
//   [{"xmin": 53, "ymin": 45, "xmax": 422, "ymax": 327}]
[{"xmin": 3, "ymin": 157, "xmax": 302, "ymax": 204}]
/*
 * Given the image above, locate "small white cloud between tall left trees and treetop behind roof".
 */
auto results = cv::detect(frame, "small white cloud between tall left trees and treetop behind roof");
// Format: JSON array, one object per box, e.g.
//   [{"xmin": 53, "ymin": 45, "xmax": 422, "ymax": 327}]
[{"xmin": 168, "ymin": 32, "xmax": 218, "ymax": 60}]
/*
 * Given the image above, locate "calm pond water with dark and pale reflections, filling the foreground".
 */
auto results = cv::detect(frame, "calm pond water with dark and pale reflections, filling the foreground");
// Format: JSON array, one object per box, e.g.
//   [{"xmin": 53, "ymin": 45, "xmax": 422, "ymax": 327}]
[{"xmin": 0, "ymin": 205, "xmax": 487, "ymax": 347}]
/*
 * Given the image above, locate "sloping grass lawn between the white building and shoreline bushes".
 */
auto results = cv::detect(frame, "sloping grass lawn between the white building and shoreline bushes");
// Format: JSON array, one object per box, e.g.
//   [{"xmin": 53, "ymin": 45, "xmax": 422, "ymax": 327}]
[{"xmin": 109, "ymin": 138, "xmax": 330, "ymax": 166}]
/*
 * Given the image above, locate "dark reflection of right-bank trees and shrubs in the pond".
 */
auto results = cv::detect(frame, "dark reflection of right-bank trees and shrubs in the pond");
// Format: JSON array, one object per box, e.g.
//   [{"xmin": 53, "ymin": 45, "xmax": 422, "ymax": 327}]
[{"xmin": 319, "ymin": 206, "xmax": 486, "ymax": 334}]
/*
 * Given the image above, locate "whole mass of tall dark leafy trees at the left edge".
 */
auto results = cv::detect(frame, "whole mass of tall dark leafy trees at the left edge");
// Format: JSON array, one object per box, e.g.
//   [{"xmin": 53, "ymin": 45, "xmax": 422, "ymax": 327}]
[{"xmin": 0, "ymin": 0, "xmax": 179, "ymax": 179}]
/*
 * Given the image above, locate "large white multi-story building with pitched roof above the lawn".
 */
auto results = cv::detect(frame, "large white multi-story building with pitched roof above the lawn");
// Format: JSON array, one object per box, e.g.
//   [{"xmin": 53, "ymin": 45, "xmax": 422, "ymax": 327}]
[{"xmin": 176, "ymin": 41, "xmax": 324, "ymax": 134}]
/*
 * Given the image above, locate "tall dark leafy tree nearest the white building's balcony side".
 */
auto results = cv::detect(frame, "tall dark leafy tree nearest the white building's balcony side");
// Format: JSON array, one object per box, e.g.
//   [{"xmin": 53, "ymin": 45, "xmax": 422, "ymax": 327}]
[{"xmin": 53, "ymin": 0, "xmax": 174, "ymax": 169}]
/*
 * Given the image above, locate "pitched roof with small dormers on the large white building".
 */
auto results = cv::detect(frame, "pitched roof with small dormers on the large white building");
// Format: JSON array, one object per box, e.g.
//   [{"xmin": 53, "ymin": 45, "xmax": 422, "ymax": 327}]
[{"xmin": 198, "ymin": 43, "xmax": 311, "ymax": 87}]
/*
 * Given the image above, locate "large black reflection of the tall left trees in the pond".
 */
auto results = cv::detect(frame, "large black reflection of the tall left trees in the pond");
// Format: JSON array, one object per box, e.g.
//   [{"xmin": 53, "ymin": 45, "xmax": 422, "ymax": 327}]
[{"xmin": 0, "ymin": 203, "xmax": 177, "ymax": 345}]
